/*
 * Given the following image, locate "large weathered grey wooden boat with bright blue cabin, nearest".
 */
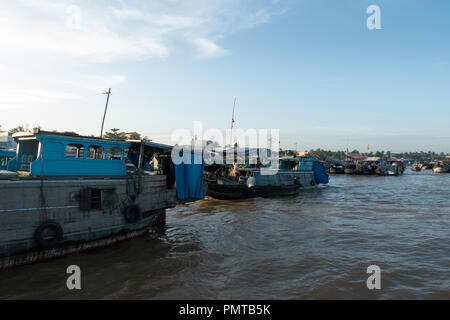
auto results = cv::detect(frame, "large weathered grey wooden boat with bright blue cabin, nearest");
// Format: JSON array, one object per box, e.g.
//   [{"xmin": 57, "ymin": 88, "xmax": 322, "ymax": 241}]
[{"xmin": 0, "ymin": 130, "xmax": 201, "ymax": 270}]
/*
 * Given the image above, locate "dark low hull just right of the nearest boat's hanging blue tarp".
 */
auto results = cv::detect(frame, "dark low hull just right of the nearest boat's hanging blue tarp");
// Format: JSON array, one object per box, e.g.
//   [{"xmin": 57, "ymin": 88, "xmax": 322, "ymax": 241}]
[{"xmin": 206, "ymin": 182, "xmax": 301, "ymax": 200}]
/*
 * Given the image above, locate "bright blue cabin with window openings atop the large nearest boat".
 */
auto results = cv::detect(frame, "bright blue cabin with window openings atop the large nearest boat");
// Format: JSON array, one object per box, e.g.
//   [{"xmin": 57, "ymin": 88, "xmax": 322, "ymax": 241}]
[{"xmin": 7, "ymin": 130, "xmax": 170, "ymax": 177}]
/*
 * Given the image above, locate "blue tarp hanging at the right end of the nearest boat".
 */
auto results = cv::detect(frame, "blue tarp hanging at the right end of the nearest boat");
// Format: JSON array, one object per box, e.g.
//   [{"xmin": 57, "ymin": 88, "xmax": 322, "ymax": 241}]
[{"xmin": 175, "ymin": 153, "xmax": 205, "ymax": 200}]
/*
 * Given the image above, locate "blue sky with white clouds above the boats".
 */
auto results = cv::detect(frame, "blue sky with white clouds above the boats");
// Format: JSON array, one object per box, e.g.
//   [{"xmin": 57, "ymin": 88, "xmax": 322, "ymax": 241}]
[{"xmin": 0, "ymin": 0, "xmax": 450, "ymax": 152}]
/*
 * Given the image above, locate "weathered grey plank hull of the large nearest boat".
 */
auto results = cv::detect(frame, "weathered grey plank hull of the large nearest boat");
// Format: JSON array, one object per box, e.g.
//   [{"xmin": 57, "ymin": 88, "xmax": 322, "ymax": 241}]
[{"xmin": 0, "ymin": 175, "xmax": 177, "ymax": 265}]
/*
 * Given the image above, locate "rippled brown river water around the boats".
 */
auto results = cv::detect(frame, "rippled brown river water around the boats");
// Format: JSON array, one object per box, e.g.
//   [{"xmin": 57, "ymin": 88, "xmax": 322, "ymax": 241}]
[{"xmin": 0, "ymin": 168, "xmax": 450, "ymax": 299}]
